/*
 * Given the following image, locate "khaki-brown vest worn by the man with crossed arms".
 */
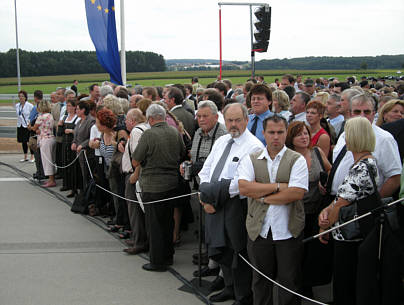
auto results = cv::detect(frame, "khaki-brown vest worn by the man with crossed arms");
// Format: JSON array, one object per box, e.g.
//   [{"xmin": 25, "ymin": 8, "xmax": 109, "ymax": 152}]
[{"xmin": 246, "ymin": 148, "xmax": 304, "ymax": 241}]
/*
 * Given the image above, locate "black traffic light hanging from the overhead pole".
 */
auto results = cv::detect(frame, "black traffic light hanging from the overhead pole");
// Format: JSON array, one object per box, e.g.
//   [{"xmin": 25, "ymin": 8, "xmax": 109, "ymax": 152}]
[{"xmin": 252, "ymin": 5, "xmax": 271, "ymax": 53}]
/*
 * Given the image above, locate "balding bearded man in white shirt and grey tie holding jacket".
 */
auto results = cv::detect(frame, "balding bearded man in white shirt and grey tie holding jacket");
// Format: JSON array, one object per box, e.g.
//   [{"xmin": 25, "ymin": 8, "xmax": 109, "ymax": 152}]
[{"xmin": 199, "ymin": 103, "xmax": 264, "ymax": 304}]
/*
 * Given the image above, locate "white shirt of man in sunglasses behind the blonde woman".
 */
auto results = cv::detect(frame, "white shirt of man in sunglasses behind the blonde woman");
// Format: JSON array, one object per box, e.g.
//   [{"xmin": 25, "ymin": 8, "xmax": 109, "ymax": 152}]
[{"xmin": 331, "ymin": 124, "xmax": 402, "ymax": 195}]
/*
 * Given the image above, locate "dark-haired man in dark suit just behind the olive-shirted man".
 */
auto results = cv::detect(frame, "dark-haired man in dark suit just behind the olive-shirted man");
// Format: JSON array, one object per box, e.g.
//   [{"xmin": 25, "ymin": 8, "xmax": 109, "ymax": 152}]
[{"xmin": 164, "ymin": 87, "xmax": 195, "ymax": 138}]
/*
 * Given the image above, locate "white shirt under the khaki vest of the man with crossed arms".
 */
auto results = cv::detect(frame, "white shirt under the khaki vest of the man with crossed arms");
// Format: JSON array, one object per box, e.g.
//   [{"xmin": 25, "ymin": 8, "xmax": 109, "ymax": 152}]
[{"xmin": 238, "ymin": 146, "xmax": 309, "ymax": 240}]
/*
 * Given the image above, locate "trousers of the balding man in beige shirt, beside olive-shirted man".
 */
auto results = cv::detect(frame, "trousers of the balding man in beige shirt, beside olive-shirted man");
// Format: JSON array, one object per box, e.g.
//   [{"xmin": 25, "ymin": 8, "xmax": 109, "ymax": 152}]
[{"xmin": 125, "ymin": 174, "xmax": 149, "ymax": 249}]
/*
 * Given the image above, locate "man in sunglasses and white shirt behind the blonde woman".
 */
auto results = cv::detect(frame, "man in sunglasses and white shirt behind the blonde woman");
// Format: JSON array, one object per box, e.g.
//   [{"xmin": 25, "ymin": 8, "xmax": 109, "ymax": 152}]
[{"xmin": 329, "ymin": 91, "xmax": 402, "ymax": 198}]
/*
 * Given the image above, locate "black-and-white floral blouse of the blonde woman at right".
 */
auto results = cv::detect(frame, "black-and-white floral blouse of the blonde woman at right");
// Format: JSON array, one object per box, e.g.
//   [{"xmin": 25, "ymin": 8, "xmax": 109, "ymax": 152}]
[{"xmin": 332, "ymin": 158, "xmax": 378, "ymax": 240}]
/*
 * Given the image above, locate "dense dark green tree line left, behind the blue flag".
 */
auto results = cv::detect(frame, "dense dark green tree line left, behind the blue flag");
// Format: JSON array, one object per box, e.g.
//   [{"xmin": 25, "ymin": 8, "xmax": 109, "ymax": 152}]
[{"xmin": 0, "ymin": 49, "xmax": 166, "ymax": 77}]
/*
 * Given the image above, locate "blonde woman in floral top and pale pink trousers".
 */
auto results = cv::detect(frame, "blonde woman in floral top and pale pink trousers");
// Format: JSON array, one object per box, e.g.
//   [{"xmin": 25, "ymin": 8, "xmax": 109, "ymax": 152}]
[{"xmin": 32, "ymin": 100, "xmax": 56, "ymax": 187}]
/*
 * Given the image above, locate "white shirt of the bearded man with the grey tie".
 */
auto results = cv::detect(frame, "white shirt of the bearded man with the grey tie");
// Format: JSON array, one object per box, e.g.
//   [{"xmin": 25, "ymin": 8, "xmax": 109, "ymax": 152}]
[{"xmin": 199, "ymin": 128, "xmax": 264, "ymax": 198}]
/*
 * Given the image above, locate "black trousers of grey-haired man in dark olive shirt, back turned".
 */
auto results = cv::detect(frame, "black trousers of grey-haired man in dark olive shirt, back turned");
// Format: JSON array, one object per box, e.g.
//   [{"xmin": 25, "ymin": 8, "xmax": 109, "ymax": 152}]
[{"xmin": 142, "ymin": 189, "xmax": 177, "ymax": 265}]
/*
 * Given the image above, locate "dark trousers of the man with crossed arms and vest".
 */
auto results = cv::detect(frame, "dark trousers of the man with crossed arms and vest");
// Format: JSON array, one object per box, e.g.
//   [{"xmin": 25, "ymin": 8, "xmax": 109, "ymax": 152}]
[{"xmin": 247, "ymin": 230, "xmax": 303, "ymax": 305}]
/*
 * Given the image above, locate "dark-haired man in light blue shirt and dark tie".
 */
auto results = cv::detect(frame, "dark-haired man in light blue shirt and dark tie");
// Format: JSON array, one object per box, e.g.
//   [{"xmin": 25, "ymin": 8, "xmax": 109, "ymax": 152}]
[{"xmin": 247, "ymin": 84, "xmax": 273, "ymax": 145}]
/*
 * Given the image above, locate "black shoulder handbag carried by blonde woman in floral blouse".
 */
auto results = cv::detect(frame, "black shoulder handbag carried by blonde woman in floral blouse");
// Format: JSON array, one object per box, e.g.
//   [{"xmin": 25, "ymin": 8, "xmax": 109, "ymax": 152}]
[{"xmin": 338, "ymin": 162, "xmax": 382, "ymax": 240}]
